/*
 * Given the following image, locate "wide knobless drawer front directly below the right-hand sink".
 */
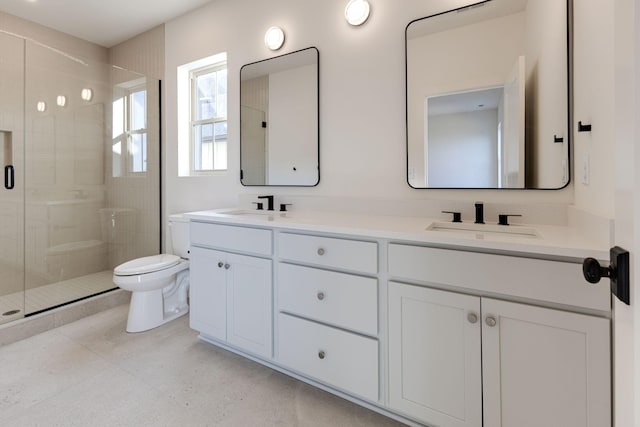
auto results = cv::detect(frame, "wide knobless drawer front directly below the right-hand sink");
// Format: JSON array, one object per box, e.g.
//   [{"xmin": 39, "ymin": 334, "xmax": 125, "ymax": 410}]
[{"xmin": 389, "ymin": 244, "xmax": 611, "ymax": 312}]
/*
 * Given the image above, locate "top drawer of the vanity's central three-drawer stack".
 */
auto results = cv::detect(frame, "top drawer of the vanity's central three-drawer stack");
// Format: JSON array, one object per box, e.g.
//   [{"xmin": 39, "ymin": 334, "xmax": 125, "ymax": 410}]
[{"xmin": 278, "ymin": 233, "xmax": 378, "ymax": 274}]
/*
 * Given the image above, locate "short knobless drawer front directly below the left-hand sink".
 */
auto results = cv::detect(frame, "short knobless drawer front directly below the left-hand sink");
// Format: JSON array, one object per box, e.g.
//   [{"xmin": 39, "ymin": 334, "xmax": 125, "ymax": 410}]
[{"xmin": 190, "ymin": 221, "xmax": 273, "ymax": 256}]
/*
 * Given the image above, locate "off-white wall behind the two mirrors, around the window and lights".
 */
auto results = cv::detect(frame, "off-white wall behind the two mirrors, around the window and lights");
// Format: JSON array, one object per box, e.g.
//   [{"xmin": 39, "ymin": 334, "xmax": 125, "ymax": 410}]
[{"xmin": 164, "ymin": 0, "xmax": 584, "ymax": 226}]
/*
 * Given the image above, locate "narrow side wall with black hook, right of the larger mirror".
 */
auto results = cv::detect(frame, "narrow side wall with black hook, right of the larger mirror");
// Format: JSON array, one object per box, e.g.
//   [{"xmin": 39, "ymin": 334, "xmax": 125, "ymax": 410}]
[{"xmin": 572, "ymin": 0, "xmax": 617, "ymax": 218}]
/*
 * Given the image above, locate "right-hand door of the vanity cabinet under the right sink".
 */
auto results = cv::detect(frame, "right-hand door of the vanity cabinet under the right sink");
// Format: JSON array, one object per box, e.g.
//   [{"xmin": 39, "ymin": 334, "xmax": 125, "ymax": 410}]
[{"xmin": 482, "ymin": 298, "xmax": 611, "ymax": 427}]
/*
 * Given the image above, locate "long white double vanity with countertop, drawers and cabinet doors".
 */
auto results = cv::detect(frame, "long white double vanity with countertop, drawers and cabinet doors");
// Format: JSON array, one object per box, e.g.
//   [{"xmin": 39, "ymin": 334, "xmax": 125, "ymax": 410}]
[{"xmin": 187, "ymin": 209, "xmax": 611, "ymax": 427}]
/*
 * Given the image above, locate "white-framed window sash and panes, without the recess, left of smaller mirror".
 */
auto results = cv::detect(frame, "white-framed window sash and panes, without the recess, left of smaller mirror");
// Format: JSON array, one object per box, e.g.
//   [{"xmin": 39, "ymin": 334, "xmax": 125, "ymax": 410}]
[{"xmin": 190, "ymin": 64, "xmax": 227, "ymax": 173}]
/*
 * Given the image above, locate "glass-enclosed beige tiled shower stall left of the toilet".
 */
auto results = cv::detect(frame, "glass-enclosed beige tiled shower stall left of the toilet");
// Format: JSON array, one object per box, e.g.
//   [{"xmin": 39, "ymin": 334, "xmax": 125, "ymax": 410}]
[{"xmin": 0, "ymin": 31, "xmax": 160, "ymax": 323}]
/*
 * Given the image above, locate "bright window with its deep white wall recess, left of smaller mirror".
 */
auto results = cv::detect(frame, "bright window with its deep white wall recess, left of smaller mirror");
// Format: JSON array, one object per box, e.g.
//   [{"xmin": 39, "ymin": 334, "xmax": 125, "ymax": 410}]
[{"xmin": 177, "ymin": 52, "xmax": 228, "ymax": 176}]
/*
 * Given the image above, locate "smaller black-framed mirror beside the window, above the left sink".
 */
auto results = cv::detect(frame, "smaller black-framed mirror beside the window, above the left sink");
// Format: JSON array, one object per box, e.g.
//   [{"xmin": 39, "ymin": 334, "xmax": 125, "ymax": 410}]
[{"xmin": 240, "ymin": 47, "xmax": 320, "ymax": 186}]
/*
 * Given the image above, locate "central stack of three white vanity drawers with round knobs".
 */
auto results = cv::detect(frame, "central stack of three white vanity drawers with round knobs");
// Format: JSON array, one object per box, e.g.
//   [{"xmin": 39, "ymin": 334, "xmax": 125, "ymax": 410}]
[{"xmin": 276, "ymin": 233, "xmax": 379, "ymax": 402}]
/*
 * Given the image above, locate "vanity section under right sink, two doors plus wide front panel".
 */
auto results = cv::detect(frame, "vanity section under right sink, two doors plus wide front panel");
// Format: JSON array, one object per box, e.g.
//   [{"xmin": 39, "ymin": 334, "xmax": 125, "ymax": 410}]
[{"xmin": 388, "ymin": 244, "xmax": 611, "ymax": 427}]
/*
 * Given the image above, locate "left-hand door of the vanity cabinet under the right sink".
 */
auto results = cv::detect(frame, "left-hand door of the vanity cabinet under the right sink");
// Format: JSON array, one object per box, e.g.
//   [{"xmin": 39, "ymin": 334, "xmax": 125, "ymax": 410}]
[{"xmin": 389, "ymin": 282, "xmax": 480, "ymax": 427}]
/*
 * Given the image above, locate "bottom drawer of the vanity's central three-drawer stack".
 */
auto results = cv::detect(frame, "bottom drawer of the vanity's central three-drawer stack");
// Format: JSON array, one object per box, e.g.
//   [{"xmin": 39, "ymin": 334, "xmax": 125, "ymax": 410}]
[{"xmin": 278, "ymin": 313, "xmax": 378, "ymax": 401}]
